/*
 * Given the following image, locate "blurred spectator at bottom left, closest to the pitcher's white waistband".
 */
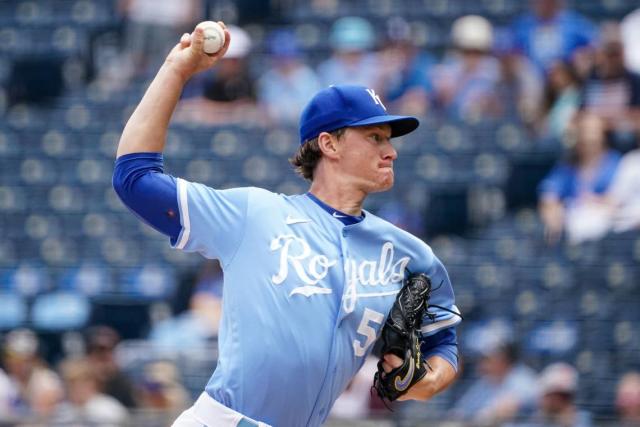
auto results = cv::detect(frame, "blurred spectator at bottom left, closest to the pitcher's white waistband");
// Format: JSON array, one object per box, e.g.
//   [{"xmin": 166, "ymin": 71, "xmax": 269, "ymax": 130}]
[{"xmin": 141, "ymin": 361, "xmax": 190, "ymax": 417}]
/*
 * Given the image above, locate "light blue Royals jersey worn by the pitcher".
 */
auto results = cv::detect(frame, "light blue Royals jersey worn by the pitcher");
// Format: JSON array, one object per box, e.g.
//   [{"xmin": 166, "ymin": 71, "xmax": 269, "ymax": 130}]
[{"xmin": 170, "ymin": 179, "xmax": 459, "ymax": 426}]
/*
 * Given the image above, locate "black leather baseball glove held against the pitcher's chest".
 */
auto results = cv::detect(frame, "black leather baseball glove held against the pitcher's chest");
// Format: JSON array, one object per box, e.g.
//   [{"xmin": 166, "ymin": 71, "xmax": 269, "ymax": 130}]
[{"xmin": 373, "ymin": 273, "xmax": 431, "ymax": 402}]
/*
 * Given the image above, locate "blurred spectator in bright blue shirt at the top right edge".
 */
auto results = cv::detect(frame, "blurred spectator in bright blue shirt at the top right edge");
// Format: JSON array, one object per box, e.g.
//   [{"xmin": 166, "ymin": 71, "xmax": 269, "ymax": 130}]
[{"xmin": 512, "ymin": 0, "xmax": 597, "ymax": 73}]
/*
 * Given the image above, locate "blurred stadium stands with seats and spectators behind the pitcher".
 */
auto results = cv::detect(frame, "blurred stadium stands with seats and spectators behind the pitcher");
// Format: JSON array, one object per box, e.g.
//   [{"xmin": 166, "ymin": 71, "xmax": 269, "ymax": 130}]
[{"xmin": 0, "ymin": 0, "xmax": 640, "ymax": 426}]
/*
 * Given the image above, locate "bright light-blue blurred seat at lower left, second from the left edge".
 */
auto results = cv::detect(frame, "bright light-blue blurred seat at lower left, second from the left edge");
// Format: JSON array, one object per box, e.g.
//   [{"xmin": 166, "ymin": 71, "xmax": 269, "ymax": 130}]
[{"xmin": 31, "ymin": 291, "xmax": 91, "ymax": 331}]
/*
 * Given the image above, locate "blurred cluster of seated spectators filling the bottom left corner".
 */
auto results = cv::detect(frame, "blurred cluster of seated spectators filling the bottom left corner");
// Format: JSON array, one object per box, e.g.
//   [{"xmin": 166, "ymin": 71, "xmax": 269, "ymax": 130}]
[{"xmin": 0, "ymin": 326, "xmax": 191, "ymax": 426}]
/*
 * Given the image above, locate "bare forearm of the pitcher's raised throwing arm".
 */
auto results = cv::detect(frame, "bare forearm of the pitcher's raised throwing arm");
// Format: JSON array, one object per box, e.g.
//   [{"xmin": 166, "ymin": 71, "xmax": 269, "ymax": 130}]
[{"xmin": 117, "ymin": 62, "xmax": 185, "ymax": 157}]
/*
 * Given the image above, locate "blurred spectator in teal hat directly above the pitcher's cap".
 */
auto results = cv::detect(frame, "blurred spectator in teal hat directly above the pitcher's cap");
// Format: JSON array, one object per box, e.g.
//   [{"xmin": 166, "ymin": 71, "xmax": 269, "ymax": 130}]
[{"xmin": 318, "ymin": 16, "xmax": 380, "ymax": 89}]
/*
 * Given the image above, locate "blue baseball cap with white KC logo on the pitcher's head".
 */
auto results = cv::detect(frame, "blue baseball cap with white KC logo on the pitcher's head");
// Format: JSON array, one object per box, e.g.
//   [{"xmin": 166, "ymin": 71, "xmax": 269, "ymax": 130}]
[{"xmin": 300, "ymin": 85, "xmax": 420, "ymax": 144}]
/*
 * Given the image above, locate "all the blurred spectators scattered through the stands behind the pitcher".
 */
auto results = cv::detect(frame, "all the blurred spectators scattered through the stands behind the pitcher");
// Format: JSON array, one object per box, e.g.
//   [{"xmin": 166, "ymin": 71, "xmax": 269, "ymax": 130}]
[{"xmin": 0, "ymin": 0, "xmax": 640, "ymax": 427}]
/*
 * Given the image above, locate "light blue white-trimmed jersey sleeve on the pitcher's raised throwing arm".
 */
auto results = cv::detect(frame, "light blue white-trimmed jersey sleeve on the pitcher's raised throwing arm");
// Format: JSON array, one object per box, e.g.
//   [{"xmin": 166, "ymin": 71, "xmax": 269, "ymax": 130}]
[{"xmin": 173, "ymin": 178, "xmax": 251, "ymax": 266}]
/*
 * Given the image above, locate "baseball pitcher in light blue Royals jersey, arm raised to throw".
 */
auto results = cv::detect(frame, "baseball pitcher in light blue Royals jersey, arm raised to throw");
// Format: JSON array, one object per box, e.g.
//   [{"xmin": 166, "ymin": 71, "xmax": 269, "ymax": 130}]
[{"xmin": 113, "ymin": 23, "xmax": 460, "ymax": 427}]
